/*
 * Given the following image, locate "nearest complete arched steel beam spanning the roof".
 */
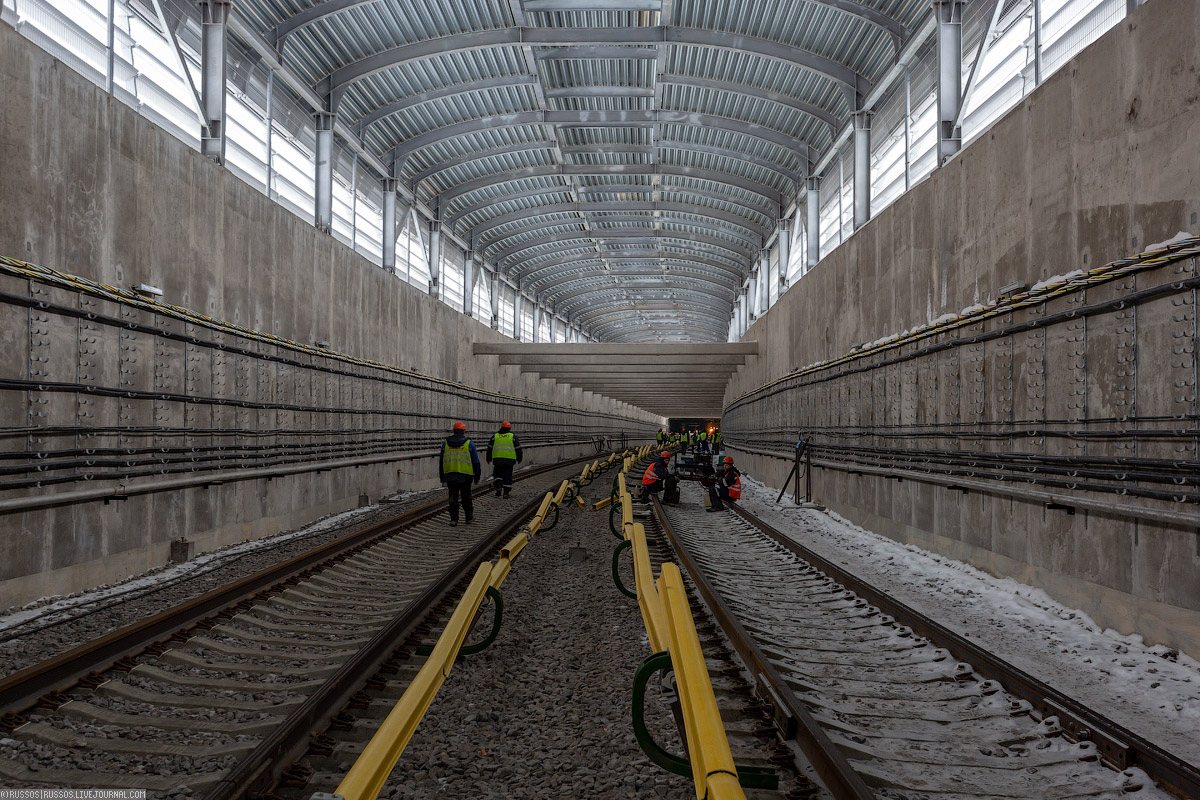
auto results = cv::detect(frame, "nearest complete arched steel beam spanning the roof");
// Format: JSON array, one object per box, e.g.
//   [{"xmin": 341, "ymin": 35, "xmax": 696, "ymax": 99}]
[{"xmin": 324, "ymin": 28, "xmax": 874, "ymax": 100}]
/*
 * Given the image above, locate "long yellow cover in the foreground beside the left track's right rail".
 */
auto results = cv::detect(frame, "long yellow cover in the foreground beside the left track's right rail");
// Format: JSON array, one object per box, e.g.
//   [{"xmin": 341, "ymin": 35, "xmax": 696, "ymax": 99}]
[{"xmin": 336, "ymin": 561, "xmax": 493, "ymax": 800}]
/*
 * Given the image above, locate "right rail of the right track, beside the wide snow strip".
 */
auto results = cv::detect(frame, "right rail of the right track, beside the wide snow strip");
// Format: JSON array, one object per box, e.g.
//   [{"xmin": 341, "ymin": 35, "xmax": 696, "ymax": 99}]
[{"xmin": 720, "ymin": 504, "xmax": 1200, "ymax": 798}]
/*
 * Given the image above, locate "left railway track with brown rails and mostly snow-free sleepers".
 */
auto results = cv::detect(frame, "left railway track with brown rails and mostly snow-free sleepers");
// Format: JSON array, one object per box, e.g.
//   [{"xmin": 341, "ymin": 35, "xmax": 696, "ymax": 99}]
[{"xmin": 0, "ymin": 459, "xmax": 604, "ymax": 800}]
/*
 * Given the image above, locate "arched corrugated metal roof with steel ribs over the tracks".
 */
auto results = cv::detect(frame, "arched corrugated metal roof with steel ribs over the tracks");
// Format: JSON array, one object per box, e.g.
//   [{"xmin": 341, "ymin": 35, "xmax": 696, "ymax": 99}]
[{"xmin": 239, "ymin": 0, "xmax": 929, "ymax": 338}]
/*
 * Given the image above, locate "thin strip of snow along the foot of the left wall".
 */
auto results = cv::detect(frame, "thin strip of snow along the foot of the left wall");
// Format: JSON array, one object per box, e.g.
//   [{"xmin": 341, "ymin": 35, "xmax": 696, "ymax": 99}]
[{"xmin": 0, "ymin": 493, "xmax": 415, "ymax": 633}]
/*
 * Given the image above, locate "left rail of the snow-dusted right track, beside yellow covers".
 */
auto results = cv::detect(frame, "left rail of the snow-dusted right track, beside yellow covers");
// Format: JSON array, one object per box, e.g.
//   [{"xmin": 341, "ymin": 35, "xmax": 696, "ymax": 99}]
[{"xmin": 653, "ymin": 498, "xmax": 875, "ymax": 800}]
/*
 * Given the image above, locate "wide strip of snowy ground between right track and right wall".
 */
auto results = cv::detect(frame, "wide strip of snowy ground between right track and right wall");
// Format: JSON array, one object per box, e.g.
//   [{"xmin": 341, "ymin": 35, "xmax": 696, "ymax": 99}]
[{"xmin": 742, "ymin": 476, "xmax": 1200, "ymax": 763}]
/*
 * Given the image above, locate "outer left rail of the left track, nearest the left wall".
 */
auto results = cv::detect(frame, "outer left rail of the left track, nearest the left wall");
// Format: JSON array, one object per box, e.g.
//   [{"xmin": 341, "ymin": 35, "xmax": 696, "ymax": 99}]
[{"xmin": 0, "ymin": 455, "xmax": 594, "ymax": 724}]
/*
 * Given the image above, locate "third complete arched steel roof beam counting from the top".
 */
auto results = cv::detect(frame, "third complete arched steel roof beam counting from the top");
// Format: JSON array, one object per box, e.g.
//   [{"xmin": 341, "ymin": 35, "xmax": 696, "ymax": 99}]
[{"xmin": 391, "ymin": 110, "xmax": 812, "ymax": 170}]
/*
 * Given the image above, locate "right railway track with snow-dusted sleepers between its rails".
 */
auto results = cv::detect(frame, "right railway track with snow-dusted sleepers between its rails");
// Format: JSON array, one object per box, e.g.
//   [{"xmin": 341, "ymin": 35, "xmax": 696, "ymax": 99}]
[{"xmin": 655, "ymin": 485, "xmax": 1200, "ymax": 800}]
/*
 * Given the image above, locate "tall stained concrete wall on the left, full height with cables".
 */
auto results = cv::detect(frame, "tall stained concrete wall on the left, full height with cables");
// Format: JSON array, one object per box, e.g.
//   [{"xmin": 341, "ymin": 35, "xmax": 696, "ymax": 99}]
[{"xmin": 0, "ymin": 18, "xmax": 660, "ymax": 607}]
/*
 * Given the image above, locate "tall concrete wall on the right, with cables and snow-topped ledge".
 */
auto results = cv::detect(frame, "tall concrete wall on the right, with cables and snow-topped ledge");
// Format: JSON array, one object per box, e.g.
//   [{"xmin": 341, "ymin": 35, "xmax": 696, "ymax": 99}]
[{"xmin": 724, "ymin": 0, "xmax": 1200, "ymax": 655}]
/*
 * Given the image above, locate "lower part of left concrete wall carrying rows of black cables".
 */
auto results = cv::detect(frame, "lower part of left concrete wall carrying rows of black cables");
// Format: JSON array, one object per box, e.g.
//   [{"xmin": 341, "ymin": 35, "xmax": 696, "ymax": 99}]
[{"xmin": 0, "ymin": 259, "xmax": 659, "ymax": 604}]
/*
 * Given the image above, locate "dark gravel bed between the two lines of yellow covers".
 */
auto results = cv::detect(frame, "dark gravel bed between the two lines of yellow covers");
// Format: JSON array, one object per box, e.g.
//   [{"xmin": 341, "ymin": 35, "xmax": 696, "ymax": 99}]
[{"xmin": 374, "ymin": 496, "xmax": 695, "ymax": 800}]
